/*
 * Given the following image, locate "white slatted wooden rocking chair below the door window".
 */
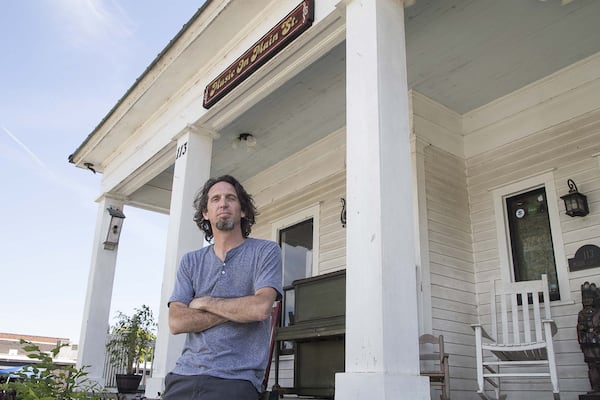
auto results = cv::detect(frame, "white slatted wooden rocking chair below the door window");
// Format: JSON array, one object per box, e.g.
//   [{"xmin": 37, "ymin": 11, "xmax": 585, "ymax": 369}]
[{"xmin": 471, "ymin": 275, "xmax": 560, "ymax": 399}]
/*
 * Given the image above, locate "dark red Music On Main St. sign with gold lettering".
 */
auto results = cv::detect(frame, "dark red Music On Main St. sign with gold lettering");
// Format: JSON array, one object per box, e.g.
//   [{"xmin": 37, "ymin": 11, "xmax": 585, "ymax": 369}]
[{"xmin": 203, "ymin": 0, "xmax": 314, "ymax": 108}]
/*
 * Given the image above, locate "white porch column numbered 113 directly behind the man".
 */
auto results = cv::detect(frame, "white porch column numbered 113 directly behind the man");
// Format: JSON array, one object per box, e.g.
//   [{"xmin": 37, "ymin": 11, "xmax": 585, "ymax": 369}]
[{"xmin": 146, "ymin": 126, "xmax": 218, "ymax": 399}]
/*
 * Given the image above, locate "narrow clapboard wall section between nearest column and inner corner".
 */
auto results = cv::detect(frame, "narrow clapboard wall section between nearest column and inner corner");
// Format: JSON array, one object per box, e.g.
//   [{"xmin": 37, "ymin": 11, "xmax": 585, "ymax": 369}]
[{"xmin": 424, "ymin": 146, "xmax": 477, "ymax": 399}]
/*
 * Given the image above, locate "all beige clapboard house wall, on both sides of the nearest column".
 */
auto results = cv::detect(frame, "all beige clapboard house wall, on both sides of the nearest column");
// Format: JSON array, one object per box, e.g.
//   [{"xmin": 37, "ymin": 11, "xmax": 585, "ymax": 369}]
[{"xmin": 245, "ymin": 52, "xmax": 600, "ymax": 399}]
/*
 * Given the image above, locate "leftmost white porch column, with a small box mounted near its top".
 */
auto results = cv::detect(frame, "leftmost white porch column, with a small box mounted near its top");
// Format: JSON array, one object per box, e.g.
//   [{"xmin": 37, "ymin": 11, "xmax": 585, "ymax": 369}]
[{"xmin": 77, "ymin": 197, "xmax": 123, "ymax": 385}]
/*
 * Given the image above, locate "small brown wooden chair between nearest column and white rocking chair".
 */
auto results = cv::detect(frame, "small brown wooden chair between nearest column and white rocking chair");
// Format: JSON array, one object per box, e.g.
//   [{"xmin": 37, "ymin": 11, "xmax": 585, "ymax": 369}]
[{"xmin": 419, "ymin": 334, "xmax": 450, "ymax": 400}]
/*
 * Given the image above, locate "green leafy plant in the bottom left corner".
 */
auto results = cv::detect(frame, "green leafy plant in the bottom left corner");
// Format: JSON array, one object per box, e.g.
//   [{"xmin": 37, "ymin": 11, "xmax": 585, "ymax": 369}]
[{"xmin": 1, "ymin": 339, "xmax": 101, "ymax": 400}]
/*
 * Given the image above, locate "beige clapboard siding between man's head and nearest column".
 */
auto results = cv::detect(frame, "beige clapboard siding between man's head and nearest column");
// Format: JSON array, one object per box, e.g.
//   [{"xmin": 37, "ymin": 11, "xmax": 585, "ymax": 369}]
[{"xmin": 245, "ymin": 126, "xmax": 346, "ymax": 274}]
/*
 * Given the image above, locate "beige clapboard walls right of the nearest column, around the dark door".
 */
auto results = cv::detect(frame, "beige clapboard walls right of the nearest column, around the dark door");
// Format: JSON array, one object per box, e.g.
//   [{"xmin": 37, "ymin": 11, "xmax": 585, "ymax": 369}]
[{"xmin": 411, "ymin": 55, "xmax": 600, "ymax": 399}]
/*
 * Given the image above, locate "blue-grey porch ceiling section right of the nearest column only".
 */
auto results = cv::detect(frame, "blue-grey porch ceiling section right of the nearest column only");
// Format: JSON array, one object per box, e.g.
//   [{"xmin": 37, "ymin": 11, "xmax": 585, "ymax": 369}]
[{"xmin": 405, "ymin": 0, "xmax": 600, "ymax": 114}]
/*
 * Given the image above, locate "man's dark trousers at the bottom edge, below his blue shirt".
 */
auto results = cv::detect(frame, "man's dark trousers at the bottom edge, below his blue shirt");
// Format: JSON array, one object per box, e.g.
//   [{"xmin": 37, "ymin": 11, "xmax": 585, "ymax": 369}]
[{"xmin": 162, "ymin": 372, "xmax": 258, "ymax": 400}]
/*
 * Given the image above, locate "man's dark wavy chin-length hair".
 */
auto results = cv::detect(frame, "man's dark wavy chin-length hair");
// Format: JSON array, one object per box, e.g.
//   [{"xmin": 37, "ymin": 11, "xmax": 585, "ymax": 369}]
[{"xmin": 194, "ymin": 175, "xmax": 258, "ymax": 242}]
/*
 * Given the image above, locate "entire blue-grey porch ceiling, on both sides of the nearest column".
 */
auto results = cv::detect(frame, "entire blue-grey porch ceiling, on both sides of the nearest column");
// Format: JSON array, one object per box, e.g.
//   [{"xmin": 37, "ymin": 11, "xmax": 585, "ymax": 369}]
[{"xmin": 129, "ymin": 0, "xmax": 600, "ymax": 209}]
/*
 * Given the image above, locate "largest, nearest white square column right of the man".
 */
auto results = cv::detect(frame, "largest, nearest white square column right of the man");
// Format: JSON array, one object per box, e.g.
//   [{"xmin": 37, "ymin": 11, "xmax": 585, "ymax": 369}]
[{"xmin": 335, "ymin": 0, "xmax": 430, "ymax": 400}]
